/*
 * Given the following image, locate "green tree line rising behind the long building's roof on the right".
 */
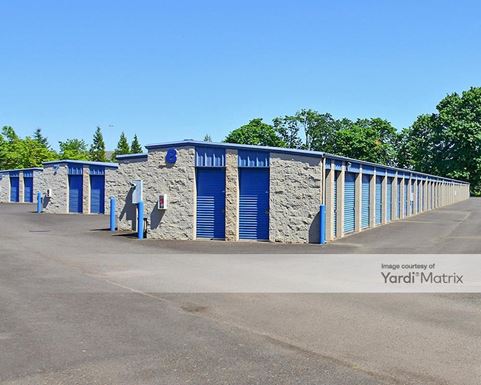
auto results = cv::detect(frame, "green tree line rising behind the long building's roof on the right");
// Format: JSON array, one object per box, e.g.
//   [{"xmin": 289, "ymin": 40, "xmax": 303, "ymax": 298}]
[{"xmin": 224, "ymin": 87, "xmax": 481, "ymax": 196}]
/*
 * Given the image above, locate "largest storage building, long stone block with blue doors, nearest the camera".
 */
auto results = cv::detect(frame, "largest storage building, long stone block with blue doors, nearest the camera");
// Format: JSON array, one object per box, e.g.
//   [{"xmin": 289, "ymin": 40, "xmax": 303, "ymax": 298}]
[{"xmin": 106, "ymin": 140, "xmax": 469, "ymax": 243}]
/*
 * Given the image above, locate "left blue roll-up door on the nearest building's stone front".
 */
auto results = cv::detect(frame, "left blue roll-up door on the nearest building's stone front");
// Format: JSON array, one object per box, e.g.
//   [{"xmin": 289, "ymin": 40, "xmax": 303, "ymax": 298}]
[{"xmin": 196, "ymin": 168, "xmax": 225, "ymax": 239}]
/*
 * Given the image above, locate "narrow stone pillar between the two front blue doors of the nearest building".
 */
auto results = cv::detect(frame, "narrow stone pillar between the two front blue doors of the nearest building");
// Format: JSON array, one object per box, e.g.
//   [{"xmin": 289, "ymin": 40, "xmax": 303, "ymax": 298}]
[{"xmin": 225, "ymin": 149, "xmax": 239, "ymax": 241}]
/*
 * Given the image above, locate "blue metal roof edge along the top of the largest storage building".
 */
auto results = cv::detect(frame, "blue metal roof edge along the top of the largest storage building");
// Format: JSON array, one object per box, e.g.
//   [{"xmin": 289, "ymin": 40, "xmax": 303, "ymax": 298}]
[{"xmin": 145, "ymin": 139, "xmax": 468, "ymax": 184}]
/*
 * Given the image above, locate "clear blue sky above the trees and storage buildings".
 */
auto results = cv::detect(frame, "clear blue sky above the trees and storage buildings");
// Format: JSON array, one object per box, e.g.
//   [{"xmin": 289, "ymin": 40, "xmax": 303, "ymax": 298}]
[{"xmin": 0, "ymin": 0, "xmax": 481, "ymax": 149}]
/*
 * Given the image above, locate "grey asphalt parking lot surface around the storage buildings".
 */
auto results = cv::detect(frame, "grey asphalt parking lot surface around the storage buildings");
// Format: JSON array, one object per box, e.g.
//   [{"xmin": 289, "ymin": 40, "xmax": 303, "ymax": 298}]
[{"xmin": 0, "ymin": 199, "xmax": 481, "ymax": 385}]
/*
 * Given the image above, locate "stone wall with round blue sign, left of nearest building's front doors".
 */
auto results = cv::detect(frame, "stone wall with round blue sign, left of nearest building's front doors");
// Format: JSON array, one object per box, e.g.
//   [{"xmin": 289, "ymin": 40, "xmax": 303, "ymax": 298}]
[{"xmin": 106, "ymin": 147, "xmax": 196, "ymax": 239}]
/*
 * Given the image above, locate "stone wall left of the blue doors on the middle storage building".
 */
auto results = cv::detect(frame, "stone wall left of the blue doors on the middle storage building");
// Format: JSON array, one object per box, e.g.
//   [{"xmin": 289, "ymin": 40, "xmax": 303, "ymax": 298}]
[{"xmin": 40, "ymin": 164, "xmax": 68, "ymax": 214}]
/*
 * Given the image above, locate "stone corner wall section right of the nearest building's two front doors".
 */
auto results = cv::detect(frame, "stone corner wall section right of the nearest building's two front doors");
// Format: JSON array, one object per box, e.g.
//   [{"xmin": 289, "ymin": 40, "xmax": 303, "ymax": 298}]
[{"xmin": 269, "ymin": 153, "xmax": 322, "ymax": 243}]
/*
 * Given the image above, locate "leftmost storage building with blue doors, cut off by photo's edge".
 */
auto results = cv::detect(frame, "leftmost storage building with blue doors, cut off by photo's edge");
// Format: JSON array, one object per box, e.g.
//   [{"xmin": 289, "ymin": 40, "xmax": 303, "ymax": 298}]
[{"xmin": 0, "ymin": 167, "xmax": 43, "ymax": 203}]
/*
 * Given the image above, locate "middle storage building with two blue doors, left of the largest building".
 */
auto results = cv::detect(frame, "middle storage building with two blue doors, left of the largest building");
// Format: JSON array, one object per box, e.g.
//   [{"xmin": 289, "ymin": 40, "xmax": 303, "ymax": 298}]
[{"xmin": 40, "ymin": 160, "xmax": 117, "ymax": 214}]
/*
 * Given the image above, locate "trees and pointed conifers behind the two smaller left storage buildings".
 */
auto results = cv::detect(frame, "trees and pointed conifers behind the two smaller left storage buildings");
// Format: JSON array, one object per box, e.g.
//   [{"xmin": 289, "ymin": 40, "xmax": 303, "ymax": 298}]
[{"xmin": 0, "ymin": 126, "xmax": 142, "ymax": 170}]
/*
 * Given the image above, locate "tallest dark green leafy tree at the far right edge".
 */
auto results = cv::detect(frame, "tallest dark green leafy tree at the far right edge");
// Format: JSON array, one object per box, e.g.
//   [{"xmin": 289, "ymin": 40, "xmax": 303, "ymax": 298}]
[{"xmin": 400, "ymin": 87, "xmax": 481, "ymax": 196}]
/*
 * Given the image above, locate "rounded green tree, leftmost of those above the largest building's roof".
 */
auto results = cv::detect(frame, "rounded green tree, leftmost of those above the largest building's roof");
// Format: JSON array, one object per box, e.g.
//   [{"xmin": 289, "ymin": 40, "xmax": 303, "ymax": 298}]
[{"xmin": 224, "ymin": 118, "xmax": 285, "ymax": 147}]
